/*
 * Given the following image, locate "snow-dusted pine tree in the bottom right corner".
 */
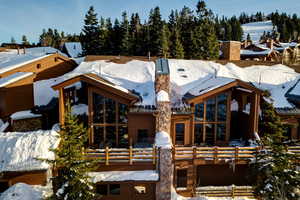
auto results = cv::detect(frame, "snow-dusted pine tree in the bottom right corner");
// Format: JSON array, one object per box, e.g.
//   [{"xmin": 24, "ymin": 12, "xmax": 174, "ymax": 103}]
[{"xmin": 252, "ymin": 94, "xmax": 300, "ymax": 200}]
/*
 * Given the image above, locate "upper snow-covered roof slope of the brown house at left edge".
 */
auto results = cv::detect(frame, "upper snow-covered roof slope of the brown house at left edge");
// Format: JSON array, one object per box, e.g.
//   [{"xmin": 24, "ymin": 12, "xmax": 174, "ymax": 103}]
[{"xmin": 0, "ymin": 47, "xmax": 65, "ymax": 74}]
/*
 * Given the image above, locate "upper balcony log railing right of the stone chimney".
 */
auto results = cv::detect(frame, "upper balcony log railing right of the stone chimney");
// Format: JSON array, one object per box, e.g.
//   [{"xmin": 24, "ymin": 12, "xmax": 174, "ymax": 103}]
[{"xmin": 174, "ymin": 146, "xmax": 300, "ymax": 162}]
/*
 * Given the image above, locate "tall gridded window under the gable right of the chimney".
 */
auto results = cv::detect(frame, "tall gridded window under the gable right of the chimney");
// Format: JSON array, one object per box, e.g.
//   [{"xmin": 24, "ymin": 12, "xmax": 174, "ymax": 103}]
[{"xmin": 194, "ymin": 93, "xmax": 228, "ymax": 145}]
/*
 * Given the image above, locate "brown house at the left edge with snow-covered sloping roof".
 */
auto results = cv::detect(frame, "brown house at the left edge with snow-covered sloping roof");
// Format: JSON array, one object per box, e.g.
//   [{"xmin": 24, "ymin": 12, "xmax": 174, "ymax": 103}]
[{"xmin": 0, "ymin": 47, "xmax": 77, "ymax": 119}]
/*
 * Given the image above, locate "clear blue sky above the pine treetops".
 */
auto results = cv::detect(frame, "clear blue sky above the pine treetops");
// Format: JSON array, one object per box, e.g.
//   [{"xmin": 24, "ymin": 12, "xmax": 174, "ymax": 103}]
[{"xmin": 0, "ymin": 0, "xmax": 300, "ymax": 44}]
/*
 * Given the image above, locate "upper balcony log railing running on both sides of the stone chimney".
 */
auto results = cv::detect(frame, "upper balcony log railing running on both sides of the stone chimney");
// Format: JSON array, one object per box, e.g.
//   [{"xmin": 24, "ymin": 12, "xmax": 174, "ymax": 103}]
[{"xmin": 85, "ymin": 146, "xmax": 300, "ymax": 165}]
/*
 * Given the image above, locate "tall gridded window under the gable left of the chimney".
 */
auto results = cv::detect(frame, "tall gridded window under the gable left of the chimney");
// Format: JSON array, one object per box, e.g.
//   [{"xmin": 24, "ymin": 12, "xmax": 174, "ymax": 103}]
[{"xmin": 91, "ymin": 93, "xmax": 128, "ymax": 148}]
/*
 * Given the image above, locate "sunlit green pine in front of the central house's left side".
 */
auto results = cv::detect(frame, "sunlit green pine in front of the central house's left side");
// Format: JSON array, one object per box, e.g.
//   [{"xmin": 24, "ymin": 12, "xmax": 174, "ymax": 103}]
[{"xmin": 48, "ymin": 106, "xmax": 95, "ymax": 200}]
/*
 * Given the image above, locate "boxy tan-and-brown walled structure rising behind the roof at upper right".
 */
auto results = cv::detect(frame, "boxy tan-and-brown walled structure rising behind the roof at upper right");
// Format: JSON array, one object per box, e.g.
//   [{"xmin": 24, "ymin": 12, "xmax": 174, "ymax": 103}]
[{"xmin": 222, "ymin": 41, "xmax": 241, "ymax": 60}]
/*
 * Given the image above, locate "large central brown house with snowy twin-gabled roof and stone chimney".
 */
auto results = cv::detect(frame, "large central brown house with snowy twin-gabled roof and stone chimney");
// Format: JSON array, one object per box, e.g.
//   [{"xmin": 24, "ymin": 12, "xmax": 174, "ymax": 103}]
[{"xmin": 29, "ymin": 59, "xmax": 300, "ymax": 199}]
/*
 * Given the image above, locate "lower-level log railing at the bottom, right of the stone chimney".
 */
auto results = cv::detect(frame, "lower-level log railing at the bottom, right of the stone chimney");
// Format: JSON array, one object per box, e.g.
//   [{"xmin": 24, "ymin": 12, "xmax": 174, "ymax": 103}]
[{"xmin": 196, "ymin": 185, "xmax": 254, "ymax": 198}]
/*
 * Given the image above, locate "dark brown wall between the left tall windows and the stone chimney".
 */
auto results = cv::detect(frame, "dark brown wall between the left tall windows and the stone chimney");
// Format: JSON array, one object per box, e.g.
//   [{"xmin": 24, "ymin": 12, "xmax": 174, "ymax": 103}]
[{"xmin": 128, "ymin": 113, "xmax": 155, "ymax": 143}]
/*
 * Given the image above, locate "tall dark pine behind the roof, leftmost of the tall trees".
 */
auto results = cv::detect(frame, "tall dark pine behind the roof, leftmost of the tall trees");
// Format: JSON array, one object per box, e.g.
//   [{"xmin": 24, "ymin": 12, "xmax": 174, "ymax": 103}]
[{"xmin": 81, "ymin": 6, "xmax": 101, "ymax": 55}]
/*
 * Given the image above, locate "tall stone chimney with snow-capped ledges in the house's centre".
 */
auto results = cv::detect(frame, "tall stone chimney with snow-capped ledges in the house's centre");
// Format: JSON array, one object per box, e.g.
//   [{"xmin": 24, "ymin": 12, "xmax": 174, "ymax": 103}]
[{"xmin": 155, "ymin": 59, "xmax": 174, "ymax": 200}]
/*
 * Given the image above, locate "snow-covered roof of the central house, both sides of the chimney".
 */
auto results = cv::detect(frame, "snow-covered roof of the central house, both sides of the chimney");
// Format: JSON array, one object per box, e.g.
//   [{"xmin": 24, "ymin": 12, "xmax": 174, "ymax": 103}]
[{"xmin": 34, "ymin": 59, "xmax": 300, "ymax": 108}]
